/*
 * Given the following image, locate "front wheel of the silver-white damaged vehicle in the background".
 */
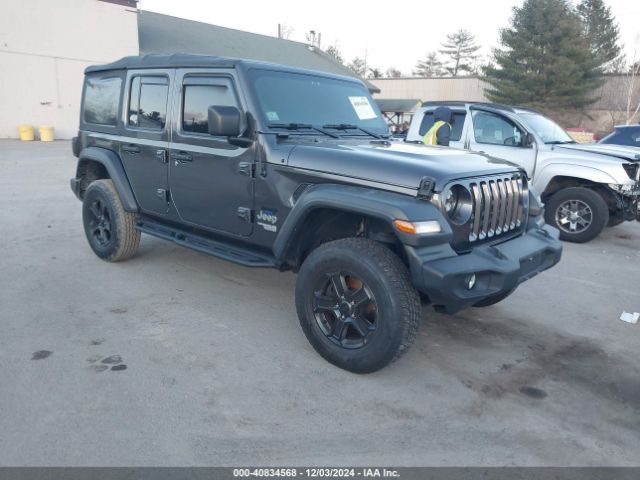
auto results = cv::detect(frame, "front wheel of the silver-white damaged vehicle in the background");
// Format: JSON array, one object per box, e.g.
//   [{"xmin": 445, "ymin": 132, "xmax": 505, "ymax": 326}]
[{"xmin": 545, "ymin": 187, "xmax": 609, "ymax": 243}]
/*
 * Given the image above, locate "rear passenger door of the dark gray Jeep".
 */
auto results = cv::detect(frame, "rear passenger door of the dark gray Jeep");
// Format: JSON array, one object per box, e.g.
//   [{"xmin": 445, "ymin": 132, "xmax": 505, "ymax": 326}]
[{"xmin": 120, "ymin": 70, "xmax": 174, "ymax": 214}]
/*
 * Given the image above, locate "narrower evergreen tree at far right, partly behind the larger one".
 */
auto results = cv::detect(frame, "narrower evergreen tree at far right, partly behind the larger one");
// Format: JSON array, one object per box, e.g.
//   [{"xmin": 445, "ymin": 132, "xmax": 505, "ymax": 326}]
[{"xmin": 576, "ymin": 0, "xmax": 621, "ymax": 71}]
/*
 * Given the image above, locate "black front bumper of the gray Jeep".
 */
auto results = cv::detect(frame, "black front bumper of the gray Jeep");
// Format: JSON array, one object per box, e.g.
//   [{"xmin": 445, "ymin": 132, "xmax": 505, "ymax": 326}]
[{"xmin": 405, "ymin": 225, "xmax": 562, "ymax": 313}]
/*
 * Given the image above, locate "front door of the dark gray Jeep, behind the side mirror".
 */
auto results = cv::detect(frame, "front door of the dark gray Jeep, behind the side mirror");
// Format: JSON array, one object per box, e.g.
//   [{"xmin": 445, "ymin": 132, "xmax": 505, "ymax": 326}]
[{"xmin": 169, "ymin": 70, "xmax": 256, "ymax": 236}]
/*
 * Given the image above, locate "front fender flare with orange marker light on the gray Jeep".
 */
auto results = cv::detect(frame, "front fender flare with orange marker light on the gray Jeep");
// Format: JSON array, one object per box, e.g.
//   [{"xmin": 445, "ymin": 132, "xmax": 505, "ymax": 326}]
[{"xmin": 273, "ymin": 183, "xmax": 453, "ymax": 259}]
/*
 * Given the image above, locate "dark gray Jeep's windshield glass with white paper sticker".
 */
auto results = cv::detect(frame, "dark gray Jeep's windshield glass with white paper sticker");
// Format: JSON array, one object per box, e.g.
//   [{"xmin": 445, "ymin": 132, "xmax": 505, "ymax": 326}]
[{"xmin": 249, "ymin": 69, "xmax": 389, "ymax": 137}]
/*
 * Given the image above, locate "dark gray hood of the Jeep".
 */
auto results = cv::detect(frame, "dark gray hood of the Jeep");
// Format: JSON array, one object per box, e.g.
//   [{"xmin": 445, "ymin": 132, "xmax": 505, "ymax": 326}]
[{"xmin": 289, "ymin": 140, "xmax": 519, "ymax": 191}]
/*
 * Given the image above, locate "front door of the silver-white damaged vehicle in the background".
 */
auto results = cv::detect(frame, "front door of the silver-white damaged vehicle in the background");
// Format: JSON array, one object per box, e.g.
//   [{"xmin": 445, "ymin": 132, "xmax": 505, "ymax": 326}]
[{"xmin": 468, "ymin": 108, "xmax": 536, "ymax": 177}]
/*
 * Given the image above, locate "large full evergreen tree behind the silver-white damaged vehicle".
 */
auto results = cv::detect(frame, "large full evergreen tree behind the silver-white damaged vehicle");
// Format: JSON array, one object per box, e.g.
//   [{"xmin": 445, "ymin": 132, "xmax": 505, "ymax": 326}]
[{"xmin": 485, "ymin": 0, "xmax": 602, "ymax": 109}]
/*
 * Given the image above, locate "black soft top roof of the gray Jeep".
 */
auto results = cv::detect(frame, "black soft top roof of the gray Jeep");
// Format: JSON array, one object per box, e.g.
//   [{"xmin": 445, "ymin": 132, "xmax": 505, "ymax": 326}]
[{"xmin": 84, "ymin": 53, "xmax": 358, "ymax": 86}]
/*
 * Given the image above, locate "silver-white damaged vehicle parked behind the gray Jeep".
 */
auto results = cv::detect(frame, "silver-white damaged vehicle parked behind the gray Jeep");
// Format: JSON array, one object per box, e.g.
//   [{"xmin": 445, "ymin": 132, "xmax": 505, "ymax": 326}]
[{"xmin": 406, "ymin": 101, "xmax": 640, "ymax": 242}]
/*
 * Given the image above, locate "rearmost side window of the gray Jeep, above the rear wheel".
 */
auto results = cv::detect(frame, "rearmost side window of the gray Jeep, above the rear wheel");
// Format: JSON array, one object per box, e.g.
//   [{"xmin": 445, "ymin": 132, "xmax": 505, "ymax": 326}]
[{"xmin": 82, "ymin": 77, "xmax": 122, "ymax": 125}]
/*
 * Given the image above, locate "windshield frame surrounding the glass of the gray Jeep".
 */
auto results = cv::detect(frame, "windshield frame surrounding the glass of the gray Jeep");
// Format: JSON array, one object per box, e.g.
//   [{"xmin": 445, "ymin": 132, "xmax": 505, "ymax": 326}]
[{"xmin": 243, "ymin": 66, "xmax": 389, "ymax": 139}]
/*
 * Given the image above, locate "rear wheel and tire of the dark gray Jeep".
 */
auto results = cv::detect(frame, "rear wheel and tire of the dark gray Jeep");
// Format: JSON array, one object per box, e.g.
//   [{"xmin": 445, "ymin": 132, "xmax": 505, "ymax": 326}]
[{"xmin": 82, "ymin": 179, "xmax": 140, "ymax": 262}]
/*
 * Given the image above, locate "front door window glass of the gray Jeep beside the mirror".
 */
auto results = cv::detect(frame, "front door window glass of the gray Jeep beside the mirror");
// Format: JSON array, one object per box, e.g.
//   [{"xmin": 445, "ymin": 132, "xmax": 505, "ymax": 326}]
[{"xmin": 182, "ymin": 77, "xmax": 238, "ymax": 134}]
